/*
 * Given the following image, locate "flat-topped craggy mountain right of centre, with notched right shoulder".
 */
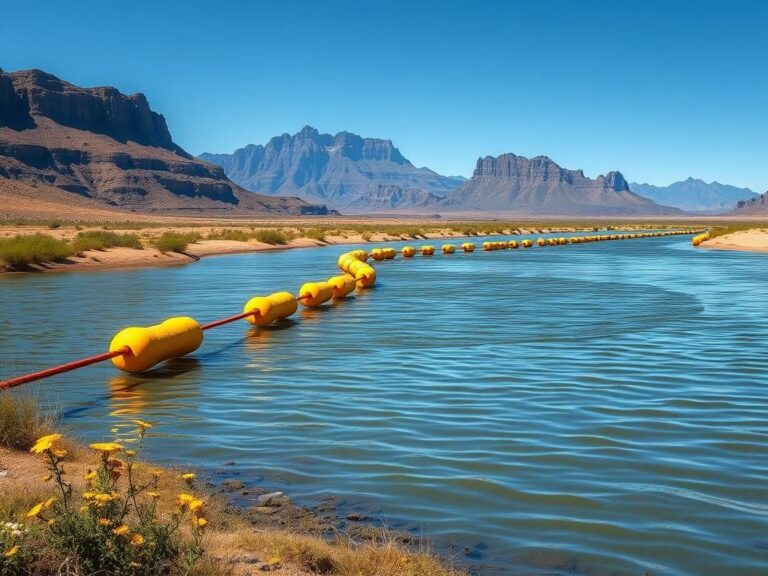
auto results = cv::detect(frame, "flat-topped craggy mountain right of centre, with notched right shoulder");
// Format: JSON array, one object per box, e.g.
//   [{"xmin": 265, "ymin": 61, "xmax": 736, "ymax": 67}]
[{"xmin": 449, "ymin": 154, "xmax": 681, "ymax": 216}]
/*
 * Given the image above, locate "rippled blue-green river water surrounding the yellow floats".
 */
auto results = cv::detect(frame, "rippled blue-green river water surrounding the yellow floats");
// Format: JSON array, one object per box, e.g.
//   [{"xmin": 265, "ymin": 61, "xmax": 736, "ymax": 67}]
[{"xmin": 0, "ymin": 237, "xmax": 768, "ymax": 576}]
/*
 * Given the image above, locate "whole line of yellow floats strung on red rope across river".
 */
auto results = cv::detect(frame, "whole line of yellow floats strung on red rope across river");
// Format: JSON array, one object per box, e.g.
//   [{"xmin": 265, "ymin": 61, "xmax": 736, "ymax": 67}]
[{"xmin": 0, "ymin": 230, "xmax": 710, "ymax": 390}]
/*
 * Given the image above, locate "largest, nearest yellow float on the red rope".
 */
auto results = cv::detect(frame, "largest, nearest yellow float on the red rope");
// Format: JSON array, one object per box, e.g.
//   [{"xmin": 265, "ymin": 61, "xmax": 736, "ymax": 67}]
[{"xmin": 109, "ymin": 316, "xmax": 203, "ymax": 372}]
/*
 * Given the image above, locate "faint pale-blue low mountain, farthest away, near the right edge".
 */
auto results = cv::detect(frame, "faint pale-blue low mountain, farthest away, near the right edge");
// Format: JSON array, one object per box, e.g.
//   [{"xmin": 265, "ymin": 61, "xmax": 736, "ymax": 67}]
[{"xmin": 629, "ymin": 178, "xmax": 758, "ymax": 212}]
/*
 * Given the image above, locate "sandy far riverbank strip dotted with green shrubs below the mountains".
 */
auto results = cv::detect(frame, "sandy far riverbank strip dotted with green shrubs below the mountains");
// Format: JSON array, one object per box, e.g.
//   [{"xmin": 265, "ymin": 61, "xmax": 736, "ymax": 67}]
[{"xmin": 0, "ymin": 218, "xmax": 759, "ymax": 270}]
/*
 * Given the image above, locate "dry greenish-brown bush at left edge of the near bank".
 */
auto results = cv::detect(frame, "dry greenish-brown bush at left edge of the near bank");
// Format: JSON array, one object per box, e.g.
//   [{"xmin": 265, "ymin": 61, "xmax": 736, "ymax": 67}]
[{"xmin": 0, "ymin": 391, "xmax": 56, "ymax": 450}]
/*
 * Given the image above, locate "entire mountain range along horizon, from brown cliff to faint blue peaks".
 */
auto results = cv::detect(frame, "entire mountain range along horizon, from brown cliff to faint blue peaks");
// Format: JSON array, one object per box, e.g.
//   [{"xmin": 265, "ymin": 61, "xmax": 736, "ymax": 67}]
[{"xmin": 0, "ymin": 70, "xmax": 756, "ymax": 216}]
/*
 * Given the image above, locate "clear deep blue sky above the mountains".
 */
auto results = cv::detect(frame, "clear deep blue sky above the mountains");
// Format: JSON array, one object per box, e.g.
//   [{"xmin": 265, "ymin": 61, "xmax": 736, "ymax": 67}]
[{"xmin": 0, "ymin": 0, "xmax": 768, "ymax": 192}]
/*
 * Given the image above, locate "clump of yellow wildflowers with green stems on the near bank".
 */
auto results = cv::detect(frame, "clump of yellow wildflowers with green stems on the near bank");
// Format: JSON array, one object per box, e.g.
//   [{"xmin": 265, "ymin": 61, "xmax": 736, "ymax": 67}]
[{"xmin": 11, "ymin": 420, "xmax": 208, "ymax": 575}]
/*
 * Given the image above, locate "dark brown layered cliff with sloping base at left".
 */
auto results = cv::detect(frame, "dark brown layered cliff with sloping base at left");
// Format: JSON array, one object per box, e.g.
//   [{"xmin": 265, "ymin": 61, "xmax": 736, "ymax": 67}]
[{"xmin": 0, "ymin": 70, "xmax": 325, "ymax": 214}]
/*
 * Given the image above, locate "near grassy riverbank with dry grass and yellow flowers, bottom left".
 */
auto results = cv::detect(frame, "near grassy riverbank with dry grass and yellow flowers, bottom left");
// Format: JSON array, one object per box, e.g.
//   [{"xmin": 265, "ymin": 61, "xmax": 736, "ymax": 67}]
[{"xmin": 0, "ymin": 391, "xmax": 463, "ymax": 576}]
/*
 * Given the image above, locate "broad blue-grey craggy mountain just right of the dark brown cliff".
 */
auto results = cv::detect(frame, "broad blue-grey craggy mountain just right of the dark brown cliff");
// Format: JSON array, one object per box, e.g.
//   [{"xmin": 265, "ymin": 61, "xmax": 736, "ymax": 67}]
[{"xmin": 200, "ymin": 126, "xmax": 463, "ymax": 212}]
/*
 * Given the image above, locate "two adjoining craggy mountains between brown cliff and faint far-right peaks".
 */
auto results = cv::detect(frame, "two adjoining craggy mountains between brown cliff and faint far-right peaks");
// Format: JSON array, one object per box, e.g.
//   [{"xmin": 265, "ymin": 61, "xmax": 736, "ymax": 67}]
[{"xmin": 200, "ymin": 126, "xmax": 680, "ymax": 216}]
